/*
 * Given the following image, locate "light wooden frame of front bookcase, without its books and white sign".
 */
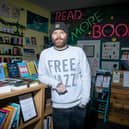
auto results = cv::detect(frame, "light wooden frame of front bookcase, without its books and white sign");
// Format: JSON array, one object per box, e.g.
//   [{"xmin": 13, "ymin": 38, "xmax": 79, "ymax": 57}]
[{"xmin": 0, "ymin": 84, "xmax": 45, "ymax": 129}]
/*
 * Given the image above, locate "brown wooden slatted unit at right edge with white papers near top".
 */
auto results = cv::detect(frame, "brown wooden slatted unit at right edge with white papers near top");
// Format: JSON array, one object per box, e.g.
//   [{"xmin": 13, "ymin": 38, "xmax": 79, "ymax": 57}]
[{"xmin": 109, "ymin": 70, "xmax": 129, "ymax": 126}]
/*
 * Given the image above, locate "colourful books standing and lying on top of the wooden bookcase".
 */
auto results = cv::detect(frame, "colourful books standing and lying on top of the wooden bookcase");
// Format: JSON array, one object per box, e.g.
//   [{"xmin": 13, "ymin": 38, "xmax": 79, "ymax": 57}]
[{"xmin": 0, "ymin": 61, "xmax": 39, "ymax": 94}]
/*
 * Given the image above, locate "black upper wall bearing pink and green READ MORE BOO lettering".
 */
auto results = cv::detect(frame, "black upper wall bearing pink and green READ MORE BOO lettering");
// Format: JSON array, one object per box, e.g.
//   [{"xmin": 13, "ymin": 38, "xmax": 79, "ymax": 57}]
[{"xmin": 51, "ymin": 3, "xmax": 129, "ymax": 44}]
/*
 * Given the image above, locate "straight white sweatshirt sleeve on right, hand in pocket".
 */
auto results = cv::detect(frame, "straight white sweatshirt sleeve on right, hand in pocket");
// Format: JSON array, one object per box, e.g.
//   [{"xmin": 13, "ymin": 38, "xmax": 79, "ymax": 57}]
[{"xmin": 80, "ymin": 49, "xmax": 91, "ymax": 105}]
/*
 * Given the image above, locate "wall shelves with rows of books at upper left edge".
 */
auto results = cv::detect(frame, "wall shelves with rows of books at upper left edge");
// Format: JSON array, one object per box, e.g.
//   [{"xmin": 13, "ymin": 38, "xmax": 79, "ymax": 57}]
[{"xmin": 0, "ymin": 18, "xmax": 25, "ymax": 62}]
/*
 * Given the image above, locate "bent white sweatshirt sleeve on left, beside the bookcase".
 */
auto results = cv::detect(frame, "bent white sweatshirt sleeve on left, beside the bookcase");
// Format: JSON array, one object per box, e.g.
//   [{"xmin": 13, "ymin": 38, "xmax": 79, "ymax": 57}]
[{"xmin": 38, "ymin": 52, "xmax": 60, "ymax": 88}]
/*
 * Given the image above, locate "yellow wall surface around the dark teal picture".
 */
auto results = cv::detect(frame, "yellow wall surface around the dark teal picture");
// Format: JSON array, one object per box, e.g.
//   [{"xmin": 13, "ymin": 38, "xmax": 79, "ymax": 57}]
[{"xmin": 8, "ymin": 0, "xmax": 50, "ymax": 60}]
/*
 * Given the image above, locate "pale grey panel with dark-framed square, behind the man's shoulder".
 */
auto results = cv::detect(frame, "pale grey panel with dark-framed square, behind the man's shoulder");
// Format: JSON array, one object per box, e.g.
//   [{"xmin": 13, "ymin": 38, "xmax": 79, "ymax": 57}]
[{"xmin": 77, "ymin": 40, "xmax": 100, "ymax": 76}]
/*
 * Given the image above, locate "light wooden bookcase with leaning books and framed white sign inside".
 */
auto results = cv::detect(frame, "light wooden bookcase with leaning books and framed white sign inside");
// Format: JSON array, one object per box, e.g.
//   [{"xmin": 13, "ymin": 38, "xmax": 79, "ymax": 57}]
[{"xmin": 0, "ymin": 84, "xmax": 45, "ymax": 129}]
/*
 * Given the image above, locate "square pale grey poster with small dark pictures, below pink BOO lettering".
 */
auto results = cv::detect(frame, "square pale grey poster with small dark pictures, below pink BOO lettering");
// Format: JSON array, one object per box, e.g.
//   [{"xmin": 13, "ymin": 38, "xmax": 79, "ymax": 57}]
[{"xmin": 102, "ymin": 42, "xmax": 120, "ymax": 60}]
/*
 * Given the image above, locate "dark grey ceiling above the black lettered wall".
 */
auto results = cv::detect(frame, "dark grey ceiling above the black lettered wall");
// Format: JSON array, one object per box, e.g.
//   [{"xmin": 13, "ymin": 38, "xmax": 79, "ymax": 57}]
[{"xmin": 28, "ymin": 0, "xmax": 129, "ymax": 11}]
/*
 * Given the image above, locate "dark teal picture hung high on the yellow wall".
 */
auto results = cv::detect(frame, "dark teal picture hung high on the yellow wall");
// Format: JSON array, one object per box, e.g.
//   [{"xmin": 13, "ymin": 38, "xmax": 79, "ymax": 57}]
[{"xmin": 27, "ymin": 11, "xmax": 48, "ymax": 33}]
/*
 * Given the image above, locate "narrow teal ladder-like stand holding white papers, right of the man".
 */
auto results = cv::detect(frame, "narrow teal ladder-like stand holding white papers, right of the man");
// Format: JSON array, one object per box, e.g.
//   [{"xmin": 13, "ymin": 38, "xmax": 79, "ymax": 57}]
[{"xmin": 92, "ymin": 70, "xmax": 111, "ymax": 123}]
